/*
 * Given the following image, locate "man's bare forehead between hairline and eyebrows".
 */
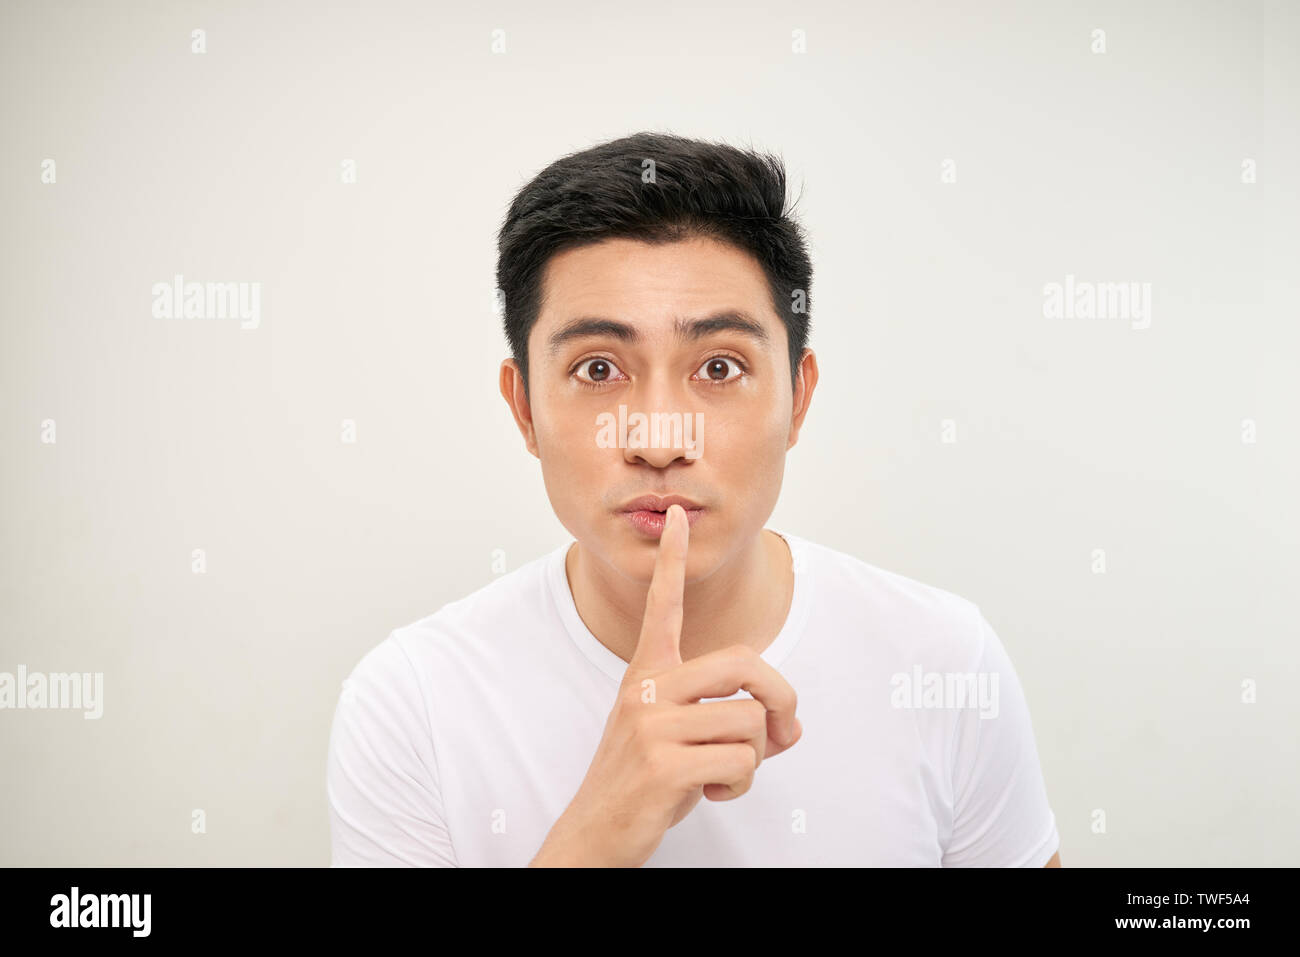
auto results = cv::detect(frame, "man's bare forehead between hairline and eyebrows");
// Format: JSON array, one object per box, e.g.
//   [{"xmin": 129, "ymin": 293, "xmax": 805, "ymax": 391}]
[{"xmin": 529, "ymin": 237, "xmax": 784, "ymax": 358}]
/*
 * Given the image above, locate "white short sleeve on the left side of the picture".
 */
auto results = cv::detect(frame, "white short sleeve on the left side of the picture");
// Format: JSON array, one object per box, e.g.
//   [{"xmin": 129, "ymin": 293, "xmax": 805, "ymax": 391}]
[{"xmin": 325, "ymin": 636, "xmax": 456, "ymax": 867}]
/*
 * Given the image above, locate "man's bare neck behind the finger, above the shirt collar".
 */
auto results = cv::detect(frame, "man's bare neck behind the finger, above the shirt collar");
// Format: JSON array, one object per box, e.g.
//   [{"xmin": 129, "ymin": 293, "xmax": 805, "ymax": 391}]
[{"xmin": 564, "ymin": 528, "xmax": 794, "ymax": 662}]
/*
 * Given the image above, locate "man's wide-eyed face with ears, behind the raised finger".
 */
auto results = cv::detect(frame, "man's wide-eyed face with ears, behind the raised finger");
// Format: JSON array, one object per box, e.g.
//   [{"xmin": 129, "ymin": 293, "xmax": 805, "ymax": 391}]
[{"xmin": 502, "ymin": 238, "xmax": 815, "ymax": 581}]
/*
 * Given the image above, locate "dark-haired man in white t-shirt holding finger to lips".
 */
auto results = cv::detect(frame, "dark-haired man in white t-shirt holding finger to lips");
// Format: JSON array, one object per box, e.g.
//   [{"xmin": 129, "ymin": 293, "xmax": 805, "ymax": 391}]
[{"xmin": 328, "ymin": 128, "xmax": 1060, "ymax": 866}]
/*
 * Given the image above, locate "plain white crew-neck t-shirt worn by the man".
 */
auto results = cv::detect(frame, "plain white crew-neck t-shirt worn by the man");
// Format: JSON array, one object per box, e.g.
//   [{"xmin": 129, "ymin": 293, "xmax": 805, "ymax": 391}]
[{"xmin": 326, "ymin": 529, "xmax": 1058, "ymax": 867}]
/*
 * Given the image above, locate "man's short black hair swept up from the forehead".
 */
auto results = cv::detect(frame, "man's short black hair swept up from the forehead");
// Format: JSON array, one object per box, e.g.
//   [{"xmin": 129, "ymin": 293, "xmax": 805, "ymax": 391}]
[{"xmin": 497, "ymin": 133, "xmax": 813, "ymax": 395}]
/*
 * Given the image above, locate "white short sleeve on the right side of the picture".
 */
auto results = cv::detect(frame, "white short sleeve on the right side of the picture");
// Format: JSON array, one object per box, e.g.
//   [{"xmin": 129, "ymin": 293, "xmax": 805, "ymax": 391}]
[{"xmin": 943, "ymin": 615, "xmax": 1060, "ymax": 867}]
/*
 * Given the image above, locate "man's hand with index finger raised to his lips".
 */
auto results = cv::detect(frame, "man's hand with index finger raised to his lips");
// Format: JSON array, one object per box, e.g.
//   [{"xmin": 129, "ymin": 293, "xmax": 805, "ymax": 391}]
[{"xmin": 533, "ymin": 505, "xmax": 802, "ymax": 867}]
